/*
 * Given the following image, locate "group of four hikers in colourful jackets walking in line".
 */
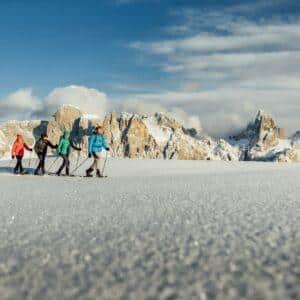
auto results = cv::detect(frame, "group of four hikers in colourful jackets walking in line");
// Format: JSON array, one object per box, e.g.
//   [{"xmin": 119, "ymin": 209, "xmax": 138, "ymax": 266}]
[{"xmin": 11, "ymin": 126, "xmax": 110, "ymax": 177}]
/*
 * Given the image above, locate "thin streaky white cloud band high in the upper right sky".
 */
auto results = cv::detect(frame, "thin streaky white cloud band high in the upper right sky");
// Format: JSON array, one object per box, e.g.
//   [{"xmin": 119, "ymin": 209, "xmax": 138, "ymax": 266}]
[{"xmin": 130, "ymin": 21, "xmax": 300, "ymax": 55}]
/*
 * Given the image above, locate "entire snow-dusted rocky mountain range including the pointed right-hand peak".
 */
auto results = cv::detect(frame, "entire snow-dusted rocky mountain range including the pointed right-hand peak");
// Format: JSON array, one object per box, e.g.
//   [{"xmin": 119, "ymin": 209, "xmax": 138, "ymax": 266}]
[{"xmin": 0, "ymin": 105, "xmax": 300, "ymax": 162}]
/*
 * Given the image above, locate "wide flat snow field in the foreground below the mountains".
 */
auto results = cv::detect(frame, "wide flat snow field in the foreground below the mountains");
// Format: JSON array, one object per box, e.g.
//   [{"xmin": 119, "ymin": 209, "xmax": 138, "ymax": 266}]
[{"xmin": 0, "ymin": 159, "xmax": 300, "ymax": 300}]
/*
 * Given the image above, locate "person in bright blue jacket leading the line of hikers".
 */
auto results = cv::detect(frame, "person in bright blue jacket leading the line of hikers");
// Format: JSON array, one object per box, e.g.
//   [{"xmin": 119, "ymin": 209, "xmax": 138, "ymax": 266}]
[{"xmin": 86, "ymin": 126, "xmax": 109, "ymax": 177}]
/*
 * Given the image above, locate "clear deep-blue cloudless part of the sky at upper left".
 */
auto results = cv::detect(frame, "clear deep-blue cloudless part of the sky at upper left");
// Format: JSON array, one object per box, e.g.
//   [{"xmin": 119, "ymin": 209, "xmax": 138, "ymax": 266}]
[{"xmin": 0, "ymin": 0, "xmax": 180, "ymax": 94}]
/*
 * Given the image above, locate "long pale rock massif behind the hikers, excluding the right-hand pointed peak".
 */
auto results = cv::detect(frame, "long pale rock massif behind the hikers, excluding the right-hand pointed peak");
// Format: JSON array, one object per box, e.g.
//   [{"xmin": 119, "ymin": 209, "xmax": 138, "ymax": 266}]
[{"xmin": 0, "ymin": 105, "xmax": 233, "ymax": 160}]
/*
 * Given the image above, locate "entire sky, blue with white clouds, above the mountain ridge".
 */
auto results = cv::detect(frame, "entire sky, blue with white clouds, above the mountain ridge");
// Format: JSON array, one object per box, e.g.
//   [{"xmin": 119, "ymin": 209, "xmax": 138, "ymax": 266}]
[{"xmin": 0, "ymin": 0, "xmax": 300, "ymax": 135}]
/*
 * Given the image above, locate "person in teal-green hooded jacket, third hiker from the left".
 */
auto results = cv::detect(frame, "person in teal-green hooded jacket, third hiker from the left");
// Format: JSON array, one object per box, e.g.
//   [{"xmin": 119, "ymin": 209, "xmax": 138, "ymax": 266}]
[{"xmin": 56, "ymin": 130, "xmax": 81, "ymax": 176}]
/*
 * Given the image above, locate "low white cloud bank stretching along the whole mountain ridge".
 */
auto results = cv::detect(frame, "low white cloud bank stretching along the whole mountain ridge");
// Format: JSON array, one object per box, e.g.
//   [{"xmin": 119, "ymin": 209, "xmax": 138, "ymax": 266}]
[{"xmin": 0, "ymin": 83, "xmax": 300, "ymax": 136}]
